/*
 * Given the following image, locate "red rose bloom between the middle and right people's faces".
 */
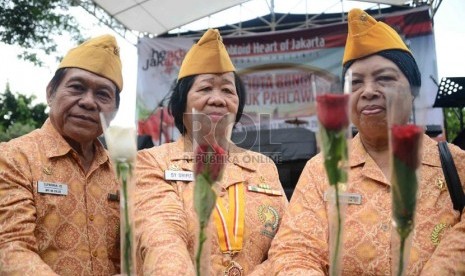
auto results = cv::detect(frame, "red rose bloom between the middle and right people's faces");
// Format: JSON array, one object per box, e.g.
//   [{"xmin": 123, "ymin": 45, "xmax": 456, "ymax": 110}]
[{"xmin": 316, "ymin": 94, "xmax": 350, "ymax": 131}]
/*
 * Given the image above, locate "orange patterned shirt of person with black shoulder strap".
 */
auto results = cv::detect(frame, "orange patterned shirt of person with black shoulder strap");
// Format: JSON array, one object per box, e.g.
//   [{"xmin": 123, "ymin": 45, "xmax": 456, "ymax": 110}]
[{"xmin": 270, "ymin": 135, "xmax": 465, "ymax": 276}]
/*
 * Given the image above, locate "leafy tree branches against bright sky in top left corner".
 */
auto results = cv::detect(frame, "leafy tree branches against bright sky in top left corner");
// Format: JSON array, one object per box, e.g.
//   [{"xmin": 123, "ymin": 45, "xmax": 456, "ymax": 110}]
[{"xmin": 0, "ymin": 0, "xmax": 83, "ymax": 66}]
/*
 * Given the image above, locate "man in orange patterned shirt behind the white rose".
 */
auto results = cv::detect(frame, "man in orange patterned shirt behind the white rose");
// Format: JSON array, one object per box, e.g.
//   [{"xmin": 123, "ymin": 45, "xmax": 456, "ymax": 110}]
[{"xmin": 0, "ymin": 35, "xmax": 123, "ymax": 275}]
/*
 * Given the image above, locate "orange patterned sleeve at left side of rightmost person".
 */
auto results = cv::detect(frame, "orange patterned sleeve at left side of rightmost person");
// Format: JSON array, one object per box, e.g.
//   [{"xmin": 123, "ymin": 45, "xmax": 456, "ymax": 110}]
[{"xmin": 269, "ymin": 157, "xmax": 328, "ymax": 275}]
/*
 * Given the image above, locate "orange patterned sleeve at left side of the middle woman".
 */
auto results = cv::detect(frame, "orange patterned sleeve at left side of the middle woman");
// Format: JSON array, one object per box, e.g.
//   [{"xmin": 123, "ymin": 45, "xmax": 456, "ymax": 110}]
[{"xmin": 134, "ymin": 151, "xmax": 194, "ymax": 275}]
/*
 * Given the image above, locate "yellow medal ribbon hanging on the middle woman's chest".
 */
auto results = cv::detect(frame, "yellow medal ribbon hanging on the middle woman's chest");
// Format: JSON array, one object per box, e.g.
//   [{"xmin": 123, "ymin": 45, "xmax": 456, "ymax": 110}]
[{"xmin": 213, "ymin": 183, "xmax": 245, "ymax": 254}]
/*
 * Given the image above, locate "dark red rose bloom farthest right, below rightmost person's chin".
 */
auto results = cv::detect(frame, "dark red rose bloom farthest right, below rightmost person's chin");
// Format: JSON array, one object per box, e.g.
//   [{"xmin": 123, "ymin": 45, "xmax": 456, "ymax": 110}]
[{"xmin": 391, "ymin": 125, "xmax": 423, "ymax": 170}]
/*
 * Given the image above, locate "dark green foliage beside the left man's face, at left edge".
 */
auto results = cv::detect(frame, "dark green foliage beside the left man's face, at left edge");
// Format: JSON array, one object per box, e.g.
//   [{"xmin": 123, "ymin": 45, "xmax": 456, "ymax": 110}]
[{"xmin": 0, "ymin": 84, "xmax": 48, "ymax": 141}]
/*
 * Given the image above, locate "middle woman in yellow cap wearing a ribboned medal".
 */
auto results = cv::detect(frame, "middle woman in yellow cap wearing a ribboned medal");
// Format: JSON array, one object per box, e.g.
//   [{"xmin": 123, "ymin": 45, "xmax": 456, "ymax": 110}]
[{"xmin": 135, "ymin": 30, "xmax": 287, "ymax": 275}]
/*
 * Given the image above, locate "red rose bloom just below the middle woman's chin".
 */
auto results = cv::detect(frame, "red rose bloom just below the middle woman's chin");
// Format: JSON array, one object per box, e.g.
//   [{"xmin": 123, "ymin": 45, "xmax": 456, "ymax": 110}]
[{"xmin": 195, "ymin": 144, "xmax": 227, "ymax": 182}]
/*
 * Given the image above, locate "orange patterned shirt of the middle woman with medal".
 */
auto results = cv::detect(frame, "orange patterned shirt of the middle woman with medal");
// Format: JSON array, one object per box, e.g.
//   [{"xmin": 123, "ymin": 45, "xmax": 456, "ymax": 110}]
[{"xmin": 135, "ymin": 138, "xmax": 287, "ymax": 275}]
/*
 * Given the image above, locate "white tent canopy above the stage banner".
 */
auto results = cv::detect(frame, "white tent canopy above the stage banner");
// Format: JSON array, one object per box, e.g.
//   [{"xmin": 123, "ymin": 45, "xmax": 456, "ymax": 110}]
[{"xmin": 86, "ymin": 0, "xmax": 428, "ymax": 36}]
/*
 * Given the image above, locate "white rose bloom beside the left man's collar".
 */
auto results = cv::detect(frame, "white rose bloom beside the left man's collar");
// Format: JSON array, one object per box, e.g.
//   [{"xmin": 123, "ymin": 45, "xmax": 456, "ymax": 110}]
[{"xmin": 105, "ymin": 126, "xmax": 137, "ymax": 161}]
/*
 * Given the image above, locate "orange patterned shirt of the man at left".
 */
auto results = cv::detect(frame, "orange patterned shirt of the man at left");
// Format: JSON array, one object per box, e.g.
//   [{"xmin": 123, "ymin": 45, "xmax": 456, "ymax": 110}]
[{"xmin": 0, "ymin": 120, "xmax": 119, "ymax": 275}]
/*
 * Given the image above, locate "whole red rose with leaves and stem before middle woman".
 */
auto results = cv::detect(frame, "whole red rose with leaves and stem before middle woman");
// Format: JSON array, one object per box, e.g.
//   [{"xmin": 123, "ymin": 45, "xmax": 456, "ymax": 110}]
[{"xmin": 194, "ymin": 145, "xmax": 226, "ymax": 276}]
